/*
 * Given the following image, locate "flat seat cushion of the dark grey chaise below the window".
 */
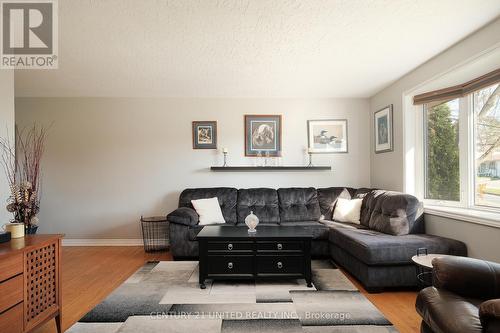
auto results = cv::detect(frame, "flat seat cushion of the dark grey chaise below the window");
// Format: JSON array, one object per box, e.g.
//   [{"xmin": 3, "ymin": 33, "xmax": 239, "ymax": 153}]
[{"xmin": 329, "ymin": 226, "xmax": 467, "ymax": 265}]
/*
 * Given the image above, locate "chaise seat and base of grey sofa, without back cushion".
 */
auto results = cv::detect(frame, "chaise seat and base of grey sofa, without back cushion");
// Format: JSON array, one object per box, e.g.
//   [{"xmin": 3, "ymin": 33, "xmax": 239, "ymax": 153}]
[{"xmin": 329, "ymin": 226, "xmax": 467, "ymax": 292}]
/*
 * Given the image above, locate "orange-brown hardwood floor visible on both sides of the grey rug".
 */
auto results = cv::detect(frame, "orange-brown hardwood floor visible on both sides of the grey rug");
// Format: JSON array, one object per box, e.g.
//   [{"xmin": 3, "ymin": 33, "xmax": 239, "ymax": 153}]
[{"xmin": 36, "ymin": 247, "xmax": 420, "ymax": 333}]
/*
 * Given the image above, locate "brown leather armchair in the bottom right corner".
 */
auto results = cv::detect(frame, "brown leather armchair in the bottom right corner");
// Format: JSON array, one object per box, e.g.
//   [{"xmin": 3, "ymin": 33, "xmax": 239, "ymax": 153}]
[{"xmin": 416, "ymin": 257, "xmax": 500, "ymax": 333}]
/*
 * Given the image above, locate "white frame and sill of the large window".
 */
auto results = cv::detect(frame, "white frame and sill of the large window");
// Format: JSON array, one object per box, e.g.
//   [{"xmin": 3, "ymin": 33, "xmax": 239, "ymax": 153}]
[{"xmin": 396, "ymin": 43, "xmax": 500, "ymax": 224}]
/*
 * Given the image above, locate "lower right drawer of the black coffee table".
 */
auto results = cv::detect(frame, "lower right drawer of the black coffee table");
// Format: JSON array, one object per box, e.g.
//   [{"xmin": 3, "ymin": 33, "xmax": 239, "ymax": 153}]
[{"xmin": 257, "ymin": 256, "xmax": 304, "ymax": 275}]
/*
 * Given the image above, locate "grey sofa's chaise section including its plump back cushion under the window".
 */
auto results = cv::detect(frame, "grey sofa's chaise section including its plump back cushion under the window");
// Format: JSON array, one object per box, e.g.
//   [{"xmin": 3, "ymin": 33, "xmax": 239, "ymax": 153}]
[{"xmin": 329, "ymin": 190, "xmax": 467, "ymax": 291}]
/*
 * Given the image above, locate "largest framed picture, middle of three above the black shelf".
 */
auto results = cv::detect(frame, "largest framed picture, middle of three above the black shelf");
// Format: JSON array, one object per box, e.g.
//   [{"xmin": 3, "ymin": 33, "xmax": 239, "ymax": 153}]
[{"xmin": 245, "ymin": 115, "xmax": 281, "ymax": 156}]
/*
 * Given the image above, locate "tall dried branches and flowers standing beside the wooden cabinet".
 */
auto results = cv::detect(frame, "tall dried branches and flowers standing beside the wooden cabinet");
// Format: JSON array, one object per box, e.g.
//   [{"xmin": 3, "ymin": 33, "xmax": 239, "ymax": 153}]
[{"xmin": 0, "ymin": 124, "xmax": 47, "ymax": 234}]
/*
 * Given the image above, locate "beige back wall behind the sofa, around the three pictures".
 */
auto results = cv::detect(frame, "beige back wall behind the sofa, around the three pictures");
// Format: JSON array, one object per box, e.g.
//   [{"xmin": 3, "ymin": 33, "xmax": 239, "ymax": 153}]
[{"xmin": 16, "ymin": 98, "xmax": 370, "ymax": 239}]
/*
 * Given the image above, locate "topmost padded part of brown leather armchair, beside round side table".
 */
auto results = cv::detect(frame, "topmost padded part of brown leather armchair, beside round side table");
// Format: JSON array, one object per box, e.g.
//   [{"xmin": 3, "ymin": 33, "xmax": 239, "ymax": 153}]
[{"xmin": 432, "ymin": 256, "xmax": 500, "ymax": 300}]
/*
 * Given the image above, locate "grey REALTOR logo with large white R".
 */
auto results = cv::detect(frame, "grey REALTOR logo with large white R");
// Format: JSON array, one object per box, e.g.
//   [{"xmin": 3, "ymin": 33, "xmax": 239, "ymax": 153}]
[{"xmin": 0, "ymin": 0, "xmax": 58, "ymax": 69}]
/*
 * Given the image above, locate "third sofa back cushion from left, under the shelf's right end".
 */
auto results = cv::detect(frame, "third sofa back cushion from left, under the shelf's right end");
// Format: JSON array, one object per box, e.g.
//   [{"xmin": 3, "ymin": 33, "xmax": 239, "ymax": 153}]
[{"xmin": 278, "ymin": 187, "xmax": 321, "ymax": 223}]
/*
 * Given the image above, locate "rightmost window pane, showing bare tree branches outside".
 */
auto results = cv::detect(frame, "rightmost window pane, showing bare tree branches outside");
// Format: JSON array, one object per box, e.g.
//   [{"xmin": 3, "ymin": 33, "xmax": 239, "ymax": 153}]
[{"xmin": 473, "ymin": 84, "xmax": 500, "ymax": 208}]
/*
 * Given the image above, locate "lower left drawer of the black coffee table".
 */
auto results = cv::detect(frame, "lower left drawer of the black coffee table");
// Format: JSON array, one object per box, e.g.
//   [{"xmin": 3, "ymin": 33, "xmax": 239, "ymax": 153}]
[{"xmin": 207, "ymin": 255, "xmax": 253, "ymax": 276}]
